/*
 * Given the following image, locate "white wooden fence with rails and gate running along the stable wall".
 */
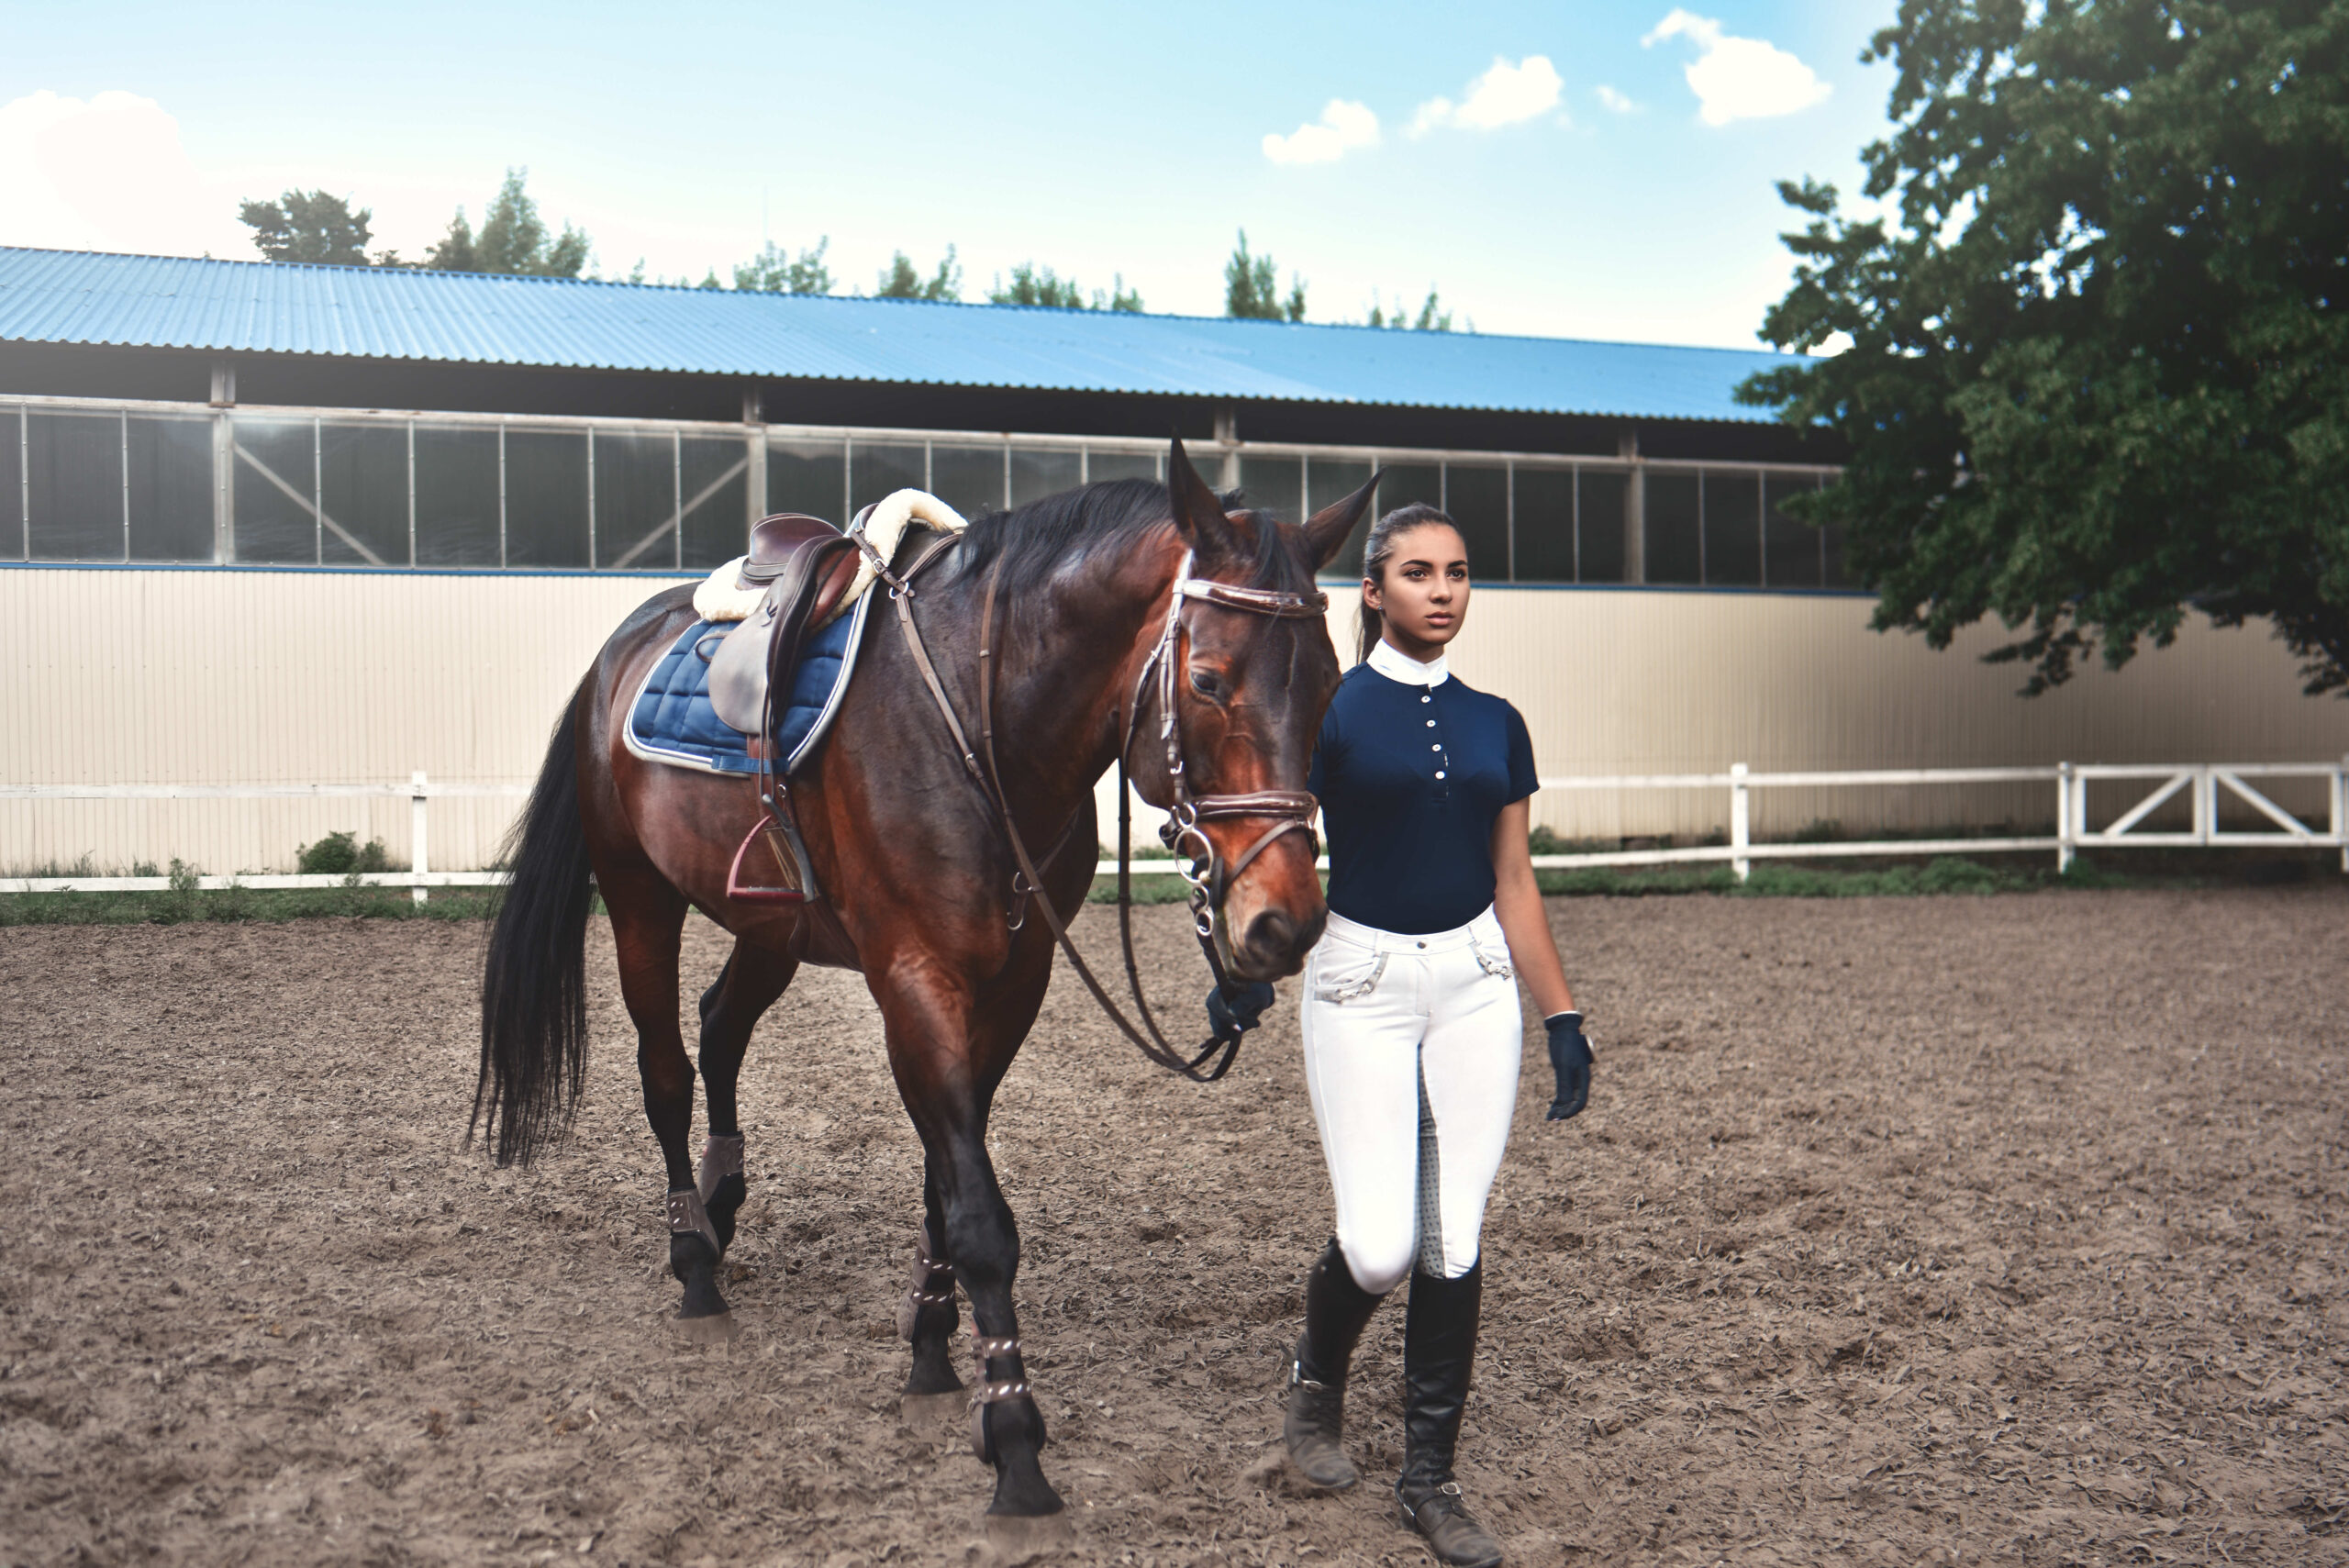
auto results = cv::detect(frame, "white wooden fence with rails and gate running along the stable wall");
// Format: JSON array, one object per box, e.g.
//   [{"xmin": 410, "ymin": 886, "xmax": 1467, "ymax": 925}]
[{"xmin": 0, "ymin": 756, "xmax": 2349, "ymax": 904}]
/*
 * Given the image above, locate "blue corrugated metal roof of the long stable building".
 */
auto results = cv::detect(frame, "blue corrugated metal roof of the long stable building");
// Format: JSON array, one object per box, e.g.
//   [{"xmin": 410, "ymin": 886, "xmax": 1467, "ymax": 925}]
[{"xmin": 0, "ymin": 247, "xmax": 1787, "ymax": 423}]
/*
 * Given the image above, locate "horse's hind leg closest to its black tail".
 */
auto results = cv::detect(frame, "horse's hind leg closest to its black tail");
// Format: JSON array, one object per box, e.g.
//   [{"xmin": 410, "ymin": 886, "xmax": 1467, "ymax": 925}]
[{"xmin": 596, "ymin": 862, "xmax": 726, "ymax": 1317}]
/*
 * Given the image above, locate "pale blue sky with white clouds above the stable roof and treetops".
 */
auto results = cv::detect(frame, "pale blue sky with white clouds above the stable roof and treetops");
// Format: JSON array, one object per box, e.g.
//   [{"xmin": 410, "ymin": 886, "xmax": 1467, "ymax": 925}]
[{"xmin": 0, "ymin": 0, "xmax": 1893, "ymax": 348}]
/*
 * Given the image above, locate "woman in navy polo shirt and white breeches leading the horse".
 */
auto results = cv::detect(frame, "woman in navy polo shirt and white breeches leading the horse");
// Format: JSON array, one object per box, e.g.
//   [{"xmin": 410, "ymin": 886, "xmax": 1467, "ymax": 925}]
[{"xmin": 1283, "ymin": 507, "xmax": 1590, "ymax": 1565}]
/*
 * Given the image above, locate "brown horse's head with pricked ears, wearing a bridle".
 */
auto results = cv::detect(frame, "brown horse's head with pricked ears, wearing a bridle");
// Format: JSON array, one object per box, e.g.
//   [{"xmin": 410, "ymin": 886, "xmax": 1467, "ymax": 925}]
[{"xmin": 1125, "ymin": 441, "xmax": 1379, "ymax": 981}]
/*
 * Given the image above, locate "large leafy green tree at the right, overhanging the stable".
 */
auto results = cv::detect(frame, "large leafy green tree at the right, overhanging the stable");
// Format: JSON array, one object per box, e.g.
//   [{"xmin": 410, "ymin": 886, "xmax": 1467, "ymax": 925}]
[{"xmin": 1741, "ymin": 0, "xmax": 2349, "ymax": 693}]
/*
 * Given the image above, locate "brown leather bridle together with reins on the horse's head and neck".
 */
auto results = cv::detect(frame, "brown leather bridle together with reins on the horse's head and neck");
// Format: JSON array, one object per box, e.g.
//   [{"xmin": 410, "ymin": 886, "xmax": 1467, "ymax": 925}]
[{"xmin": 890, "ymin": 539, "xmax": 1330, "ymax": 1082}]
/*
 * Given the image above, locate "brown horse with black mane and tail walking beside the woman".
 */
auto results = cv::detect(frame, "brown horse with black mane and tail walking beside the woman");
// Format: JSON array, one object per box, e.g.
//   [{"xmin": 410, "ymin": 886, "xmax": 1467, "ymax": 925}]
[{"xmin": 474, "ymin": 441, "xmax": 1376, "ymax": 1514}]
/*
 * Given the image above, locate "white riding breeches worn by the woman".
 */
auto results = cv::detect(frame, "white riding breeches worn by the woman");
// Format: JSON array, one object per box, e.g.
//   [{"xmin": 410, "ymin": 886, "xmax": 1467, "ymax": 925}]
[{"xmin": 1304, "ymin": 908, "xmax": 1524, "ymax": 1294}]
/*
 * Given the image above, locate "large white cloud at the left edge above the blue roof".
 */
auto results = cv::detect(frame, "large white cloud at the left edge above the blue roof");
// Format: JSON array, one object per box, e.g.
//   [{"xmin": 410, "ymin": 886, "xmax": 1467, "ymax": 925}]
[{"xmin": 0, "ymin": 89, "xmax": 249, "ymax": 256}]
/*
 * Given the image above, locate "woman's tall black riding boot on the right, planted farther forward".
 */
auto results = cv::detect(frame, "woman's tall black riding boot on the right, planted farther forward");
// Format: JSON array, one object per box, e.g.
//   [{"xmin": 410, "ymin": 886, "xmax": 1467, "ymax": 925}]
[{"xmin": 1396, "ymin": 1261, "xmax": 1501, "ymax": 1568}]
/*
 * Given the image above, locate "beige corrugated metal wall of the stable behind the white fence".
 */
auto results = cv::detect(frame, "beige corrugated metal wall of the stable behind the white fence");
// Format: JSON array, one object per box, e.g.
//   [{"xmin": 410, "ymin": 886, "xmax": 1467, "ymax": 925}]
[{"xmin": 0, "ymin": 568, "xmax": 2349, "ymax": 873}]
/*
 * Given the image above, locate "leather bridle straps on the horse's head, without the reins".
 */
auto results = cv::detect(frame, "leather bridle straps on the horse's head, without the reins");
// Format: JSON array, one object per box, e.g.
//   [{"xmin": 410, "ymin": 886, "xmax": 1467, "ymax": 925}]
[{"xmin": 1119, "ymin": 551, "xmax": 1330, "ymax": 939}]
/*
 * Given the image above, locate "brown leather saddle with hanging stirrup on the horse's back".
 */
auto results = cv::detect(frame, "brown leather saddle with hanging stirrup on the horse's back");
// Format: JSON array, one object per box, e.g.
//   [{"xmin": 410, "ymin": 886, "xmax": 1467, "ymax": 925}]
[{"xmin": 709, "ymin": 512, "xmax": 857, "ymax": 904}]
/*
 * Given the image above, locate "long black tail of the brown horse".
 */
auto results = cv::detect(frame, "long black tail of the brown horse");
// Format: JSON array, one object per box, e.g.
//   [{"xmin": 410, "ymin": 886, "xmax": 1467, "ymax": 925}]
[{"xmin": 465, "ymin": 699, "xmax": 595, "ymax": 1164}]
